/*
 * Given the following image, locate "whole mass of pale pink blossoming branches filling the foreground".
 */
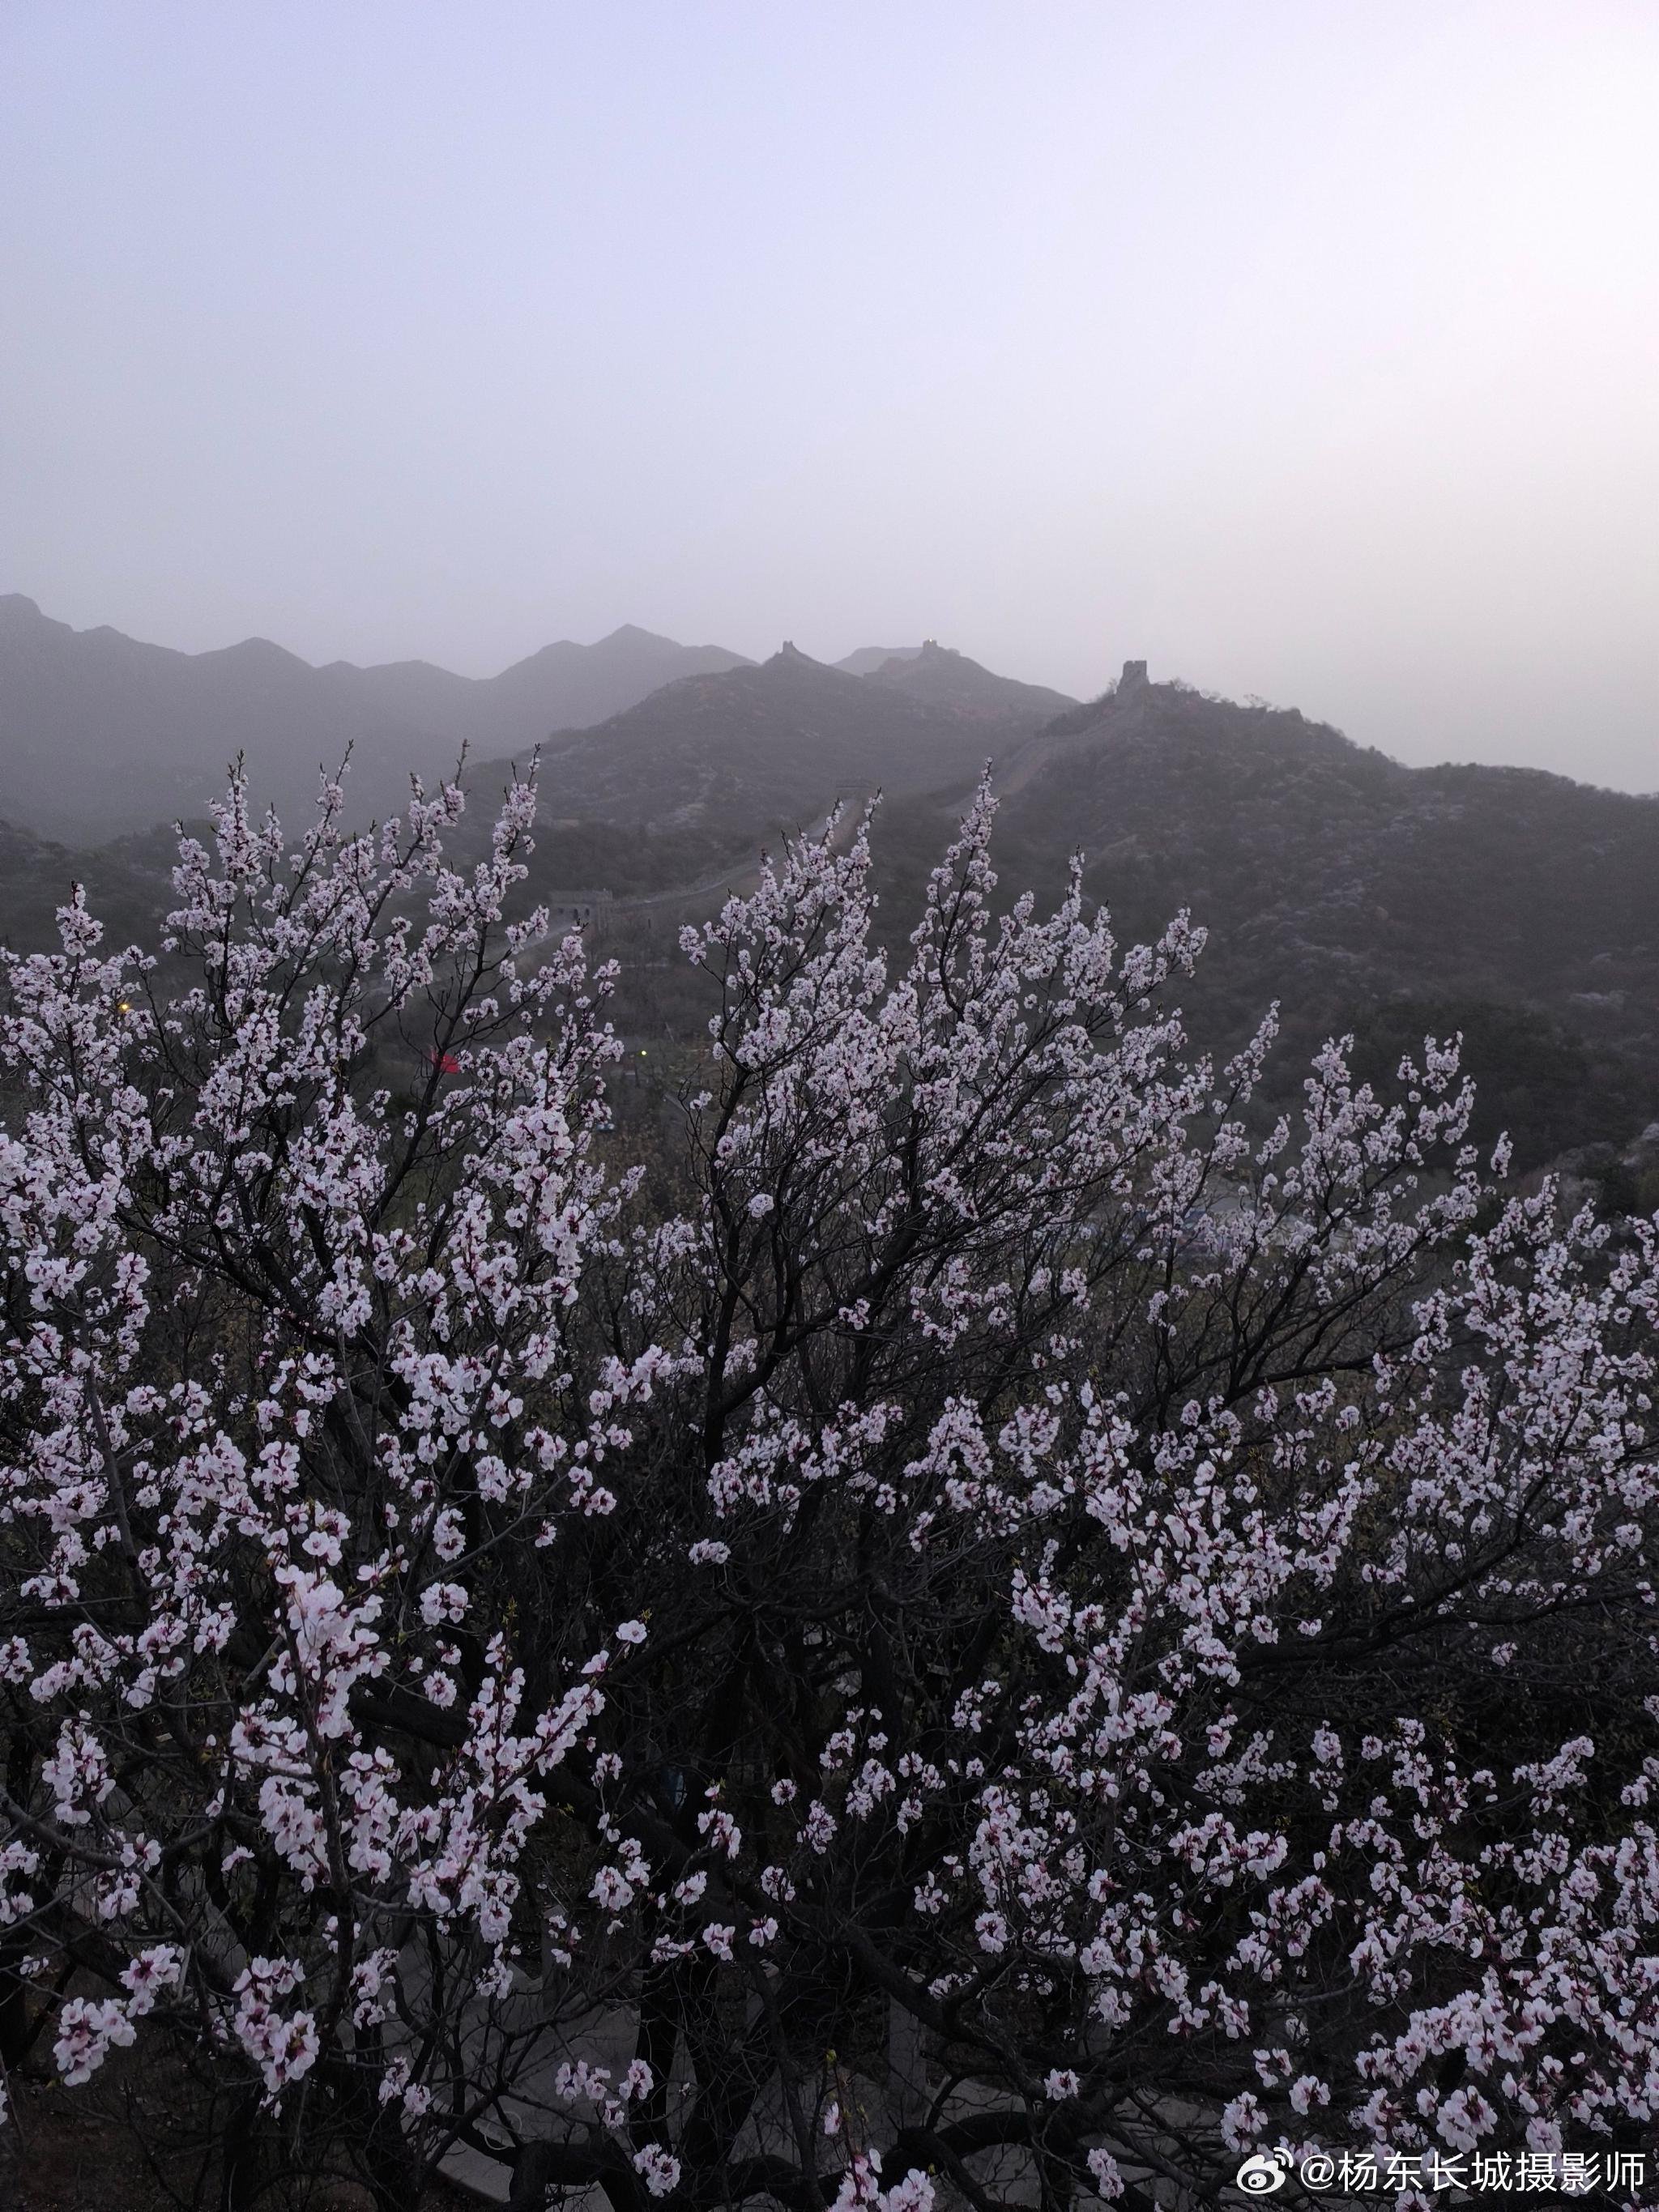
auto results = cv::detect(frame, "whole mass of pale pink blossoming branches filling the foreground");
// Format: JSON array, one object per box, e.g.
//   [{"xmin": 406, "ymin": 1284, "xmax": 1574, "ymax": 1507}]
[{"xmin": 0, "ymin": 765, "xmax": 1659, "ymax": 2212}]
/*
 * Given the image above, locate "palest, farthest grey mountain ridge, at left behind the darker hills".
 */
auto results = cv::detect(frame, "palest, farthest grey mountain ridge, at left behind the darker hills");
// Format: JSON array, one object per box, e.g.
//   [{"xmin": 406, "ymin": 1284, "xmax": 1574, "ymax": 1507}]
[{"xmin": 0, "ymin": 595, "xmax": 748, "ymax": 843}]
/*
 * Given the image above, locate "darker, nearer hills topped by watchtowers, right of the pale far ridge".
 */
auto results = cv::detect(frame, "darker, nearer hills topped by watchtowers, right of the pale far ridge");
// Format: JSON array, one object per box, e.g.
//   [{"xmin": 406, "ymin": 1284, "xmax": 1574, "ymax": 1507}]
[{"xmin": 0, "ymin": 646, "xmax": 1659, "ymax": 1176}]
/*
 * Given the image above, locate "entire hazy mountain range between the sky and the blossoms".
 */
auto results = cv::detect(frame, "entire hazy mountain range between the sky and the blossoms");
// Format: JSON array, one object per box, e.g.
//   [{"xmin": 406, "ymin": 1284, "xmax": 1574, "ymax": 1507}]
[{"xmin": 0, "ymin": 599, "xmax": 1659, "ymax": 1161}]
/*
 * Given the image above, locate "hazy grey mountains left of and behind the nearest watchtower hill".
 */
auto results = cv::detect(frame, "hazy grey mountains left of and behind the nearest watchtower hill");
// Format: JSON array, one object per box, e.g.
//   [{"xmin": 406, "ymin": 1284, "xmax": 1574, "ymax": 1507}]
[{"xmin": 0, "ymin": 595, "xmax": 1092, "ymax": 843}]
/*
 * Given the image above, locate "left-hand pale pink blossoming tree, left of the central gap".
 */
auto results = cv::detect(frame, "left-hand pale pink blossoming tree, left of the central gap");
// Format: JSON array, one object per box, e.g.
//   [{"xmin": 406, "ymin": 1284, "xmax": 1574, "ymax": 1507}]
[{"xmin": 0, "ymin": 787, "xmax": 650, "ymax": 2206}]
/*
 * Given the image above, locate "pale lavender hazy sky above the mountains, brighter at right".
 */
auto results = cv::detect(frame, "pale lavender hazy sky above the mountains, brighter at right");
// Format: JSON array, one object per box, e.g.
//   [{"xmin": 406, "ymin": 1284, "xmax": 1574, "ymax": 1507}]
[{"xmin": 0, "ymin": 0, "xmax": 1659, "ymax": 790}]
